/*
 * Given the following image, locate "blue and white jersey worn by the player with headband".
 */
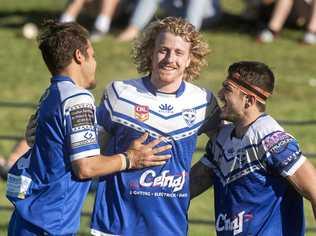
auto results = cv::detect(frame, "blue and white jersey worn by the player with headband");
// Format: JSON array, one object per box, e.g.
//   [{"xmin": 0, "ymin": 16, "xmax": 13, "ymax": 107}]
[{"xmin": 201, "ymin": 115, "xmax": 305, "ymax": 236}]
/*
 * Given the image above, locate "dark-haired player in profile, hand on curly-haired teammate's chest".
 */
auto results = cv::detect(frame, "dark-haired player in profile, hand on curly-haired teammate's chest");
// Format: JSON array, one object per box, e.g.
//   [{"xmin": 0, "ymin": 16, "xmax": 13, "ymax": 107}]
[{"xmin": 6, "ymin": 20, "xmax": 170, "ymax": 236}]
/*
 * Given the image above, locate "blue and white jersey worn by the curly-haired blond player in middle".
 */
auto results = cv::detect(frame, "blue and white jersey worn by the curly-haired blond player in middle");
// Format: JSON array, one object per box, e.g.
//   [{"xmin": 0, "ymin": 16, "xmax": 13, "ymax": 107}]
[{"xmin": 91, "ymin": 77, "xmax": 219, "ymax": 236}]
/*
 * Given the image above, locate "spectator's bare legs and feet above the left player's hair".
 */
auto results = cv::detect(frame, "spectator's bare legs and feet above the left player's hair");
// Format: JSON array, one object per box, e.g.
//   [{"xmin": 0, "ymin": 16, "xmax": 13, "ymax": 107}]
[{"xmin": 60, "ymin": 0, "xmax": 126, "ymax": 42}]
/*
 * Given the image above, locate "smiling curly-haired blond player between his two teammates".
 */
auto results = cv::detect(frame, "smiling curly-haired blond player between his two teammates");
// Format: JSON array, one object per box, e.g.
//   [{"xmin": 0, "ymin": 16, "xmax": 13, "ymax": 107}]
[{"xmin": 91, "ymin": 17, "xmax": 219, "ymax": 236}]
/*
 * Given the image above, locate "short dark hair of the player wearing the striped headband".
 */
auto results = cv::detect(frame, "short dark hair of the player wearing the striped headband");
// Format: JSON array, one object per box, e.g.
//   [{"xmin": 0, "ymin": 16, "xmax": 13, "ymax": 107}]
[{"xmin": 228, "ymin": 61, "xmax": 274, "ymax": 111}]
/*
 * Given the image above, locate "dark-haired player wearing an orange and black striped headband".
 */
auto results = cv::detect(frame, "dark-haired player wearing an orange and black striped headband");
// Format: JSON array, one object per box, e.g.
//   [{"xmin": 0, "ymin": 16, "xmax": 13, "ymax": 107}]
[{"xmin": 190, "ymin": 61, "xmax": 316, "ymax": 236}]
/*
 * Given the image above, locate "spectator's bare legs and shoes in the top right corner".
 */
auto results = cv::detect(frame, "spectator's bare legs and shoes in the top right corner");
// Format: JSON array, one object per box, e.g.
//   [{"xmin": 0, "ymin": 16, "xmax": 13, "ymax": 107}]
[{"xmin": 257, "ymin": 0, "xmax": 316, "ymax": 45}]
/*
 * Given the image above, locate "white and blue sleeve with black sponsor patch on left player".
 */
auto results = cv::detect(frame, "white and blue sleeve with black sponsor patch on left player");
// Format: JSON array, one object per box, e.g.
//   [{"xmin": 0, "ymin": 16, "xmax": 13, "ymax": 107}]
[{"xmin": 64, "ymin": 94, "xmax": 100, "ymax": 161}]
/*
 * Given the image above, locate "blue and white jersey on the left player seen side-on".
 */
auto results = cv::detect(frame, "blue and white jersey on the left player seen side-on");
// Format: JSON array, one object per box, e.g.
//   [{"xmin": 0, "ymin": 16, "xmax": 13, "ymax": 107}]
[{"xmin": 7, "ymin": 76, "xmax": 100, "ymax": 235}]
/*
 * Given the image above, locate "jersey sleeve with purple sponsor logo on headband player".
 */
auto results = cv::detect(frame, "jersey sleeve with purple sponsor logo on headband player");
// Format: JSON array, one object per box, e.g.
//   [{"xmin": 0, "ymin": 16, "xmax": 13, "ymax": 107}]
[{"xmin": 263, "ymin": 131, "xmax": 305, "ymax": 177}]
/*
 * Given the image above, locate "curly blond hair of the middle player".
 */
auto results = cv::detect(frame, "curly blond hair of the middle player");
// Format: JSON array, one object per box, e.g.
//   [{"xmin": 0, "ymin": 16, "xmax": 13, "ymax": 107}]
[{"xmin": 132, "ymin": 17, "xmax": 210, "ymax": 81}]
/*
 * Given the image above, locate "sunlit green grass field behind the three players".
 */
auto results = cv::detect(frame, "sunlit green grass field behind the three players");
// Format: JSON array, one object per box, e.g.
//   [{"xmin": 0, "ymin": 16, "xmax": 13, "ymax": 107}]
[{"xmin": 0, "ymin": 0, "xmax": 316, "ymax": 236}]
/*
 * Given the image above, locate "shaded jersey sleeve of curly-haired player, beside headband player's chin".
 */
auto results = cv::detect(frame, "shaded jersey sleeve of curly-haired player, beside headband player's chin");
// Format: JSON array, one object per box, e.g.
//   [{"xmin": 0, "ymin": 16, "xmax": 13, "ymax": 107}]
[{"xmin": 198, "ymin": 92, "xmax": 221, "ymax": 134}]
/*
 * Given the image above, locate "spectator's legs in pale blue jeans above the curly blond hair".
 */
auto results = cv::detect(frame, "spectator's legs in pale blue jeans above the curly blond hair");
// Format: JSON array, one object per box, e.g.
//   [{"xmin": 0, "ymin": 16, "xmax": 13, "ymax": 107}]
[{"xmin": 118, "ymin": 0, "xmax": 221, "ymax": 41}]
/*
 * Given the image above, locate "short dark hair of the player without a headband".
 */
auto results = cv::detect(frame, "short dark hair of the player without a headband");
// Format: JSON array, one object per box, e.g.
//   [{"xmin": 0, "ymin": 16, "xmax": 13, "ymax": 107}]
[{"xmin": 37, "ymin": 20, "xmax": 89, "ymax": 75}]
